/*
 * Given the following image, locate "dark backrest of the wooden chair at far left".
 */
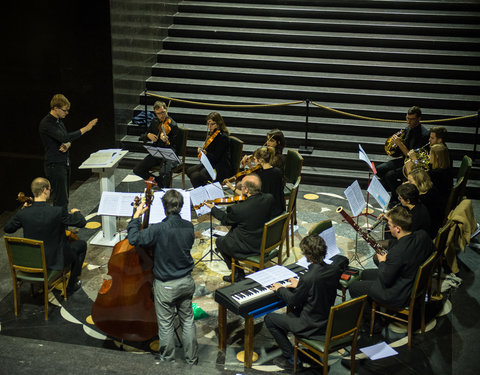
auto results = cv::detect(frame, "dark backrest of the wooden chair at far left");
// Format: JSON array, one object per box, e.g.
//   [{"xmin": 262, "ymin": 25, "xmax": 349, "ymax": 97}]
[{"xmin": 5, "ymin": 236, "xmax": 46, "ymax": 272}]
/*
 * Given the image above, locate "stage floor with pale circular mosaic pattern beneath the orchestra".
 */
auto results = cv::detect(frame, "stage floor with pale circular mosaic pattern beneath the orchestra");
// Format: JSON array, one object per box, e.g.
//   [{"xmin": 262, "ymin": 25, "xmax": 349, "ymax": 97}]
[{"xmin": 0, "ymin": 170, "xmax": 480, "ymax": 374}]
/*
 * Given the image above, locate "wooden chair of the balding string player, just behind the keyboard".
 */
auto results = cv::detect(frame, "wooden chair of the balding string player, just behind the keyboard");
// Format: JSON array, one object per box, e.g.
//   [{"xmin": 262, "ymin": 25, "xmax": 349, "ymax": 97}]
[{"xmin": 232, "ymin": 213, "xmax": 289, "ymax": 284}]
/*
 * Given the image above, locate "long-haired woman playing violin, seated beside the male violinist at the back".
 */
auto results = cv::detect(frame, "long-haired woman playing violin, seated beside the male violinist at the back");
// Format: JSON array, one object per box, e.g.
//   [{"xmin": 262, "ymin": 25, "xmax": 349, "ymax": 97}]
[{"xmin": 186, "ymin": 112, "xmax": 232, "ymax": 188}]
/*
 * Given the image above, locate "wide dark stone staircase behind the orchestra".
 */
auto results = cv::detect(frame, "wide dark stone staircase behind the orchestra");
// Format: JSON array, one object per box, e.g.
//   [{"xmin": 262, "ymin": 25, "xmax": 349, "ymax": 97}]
[{"xmin": 117, "ymin": 0, "xmax": 480, "ymax": 196}]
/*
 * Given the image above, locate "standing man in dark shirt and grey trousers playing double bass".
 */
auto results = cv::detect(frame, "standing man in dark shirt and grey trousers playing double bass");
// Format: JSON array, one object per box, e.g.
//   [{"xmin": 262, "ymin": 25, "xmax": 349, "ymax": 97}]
[{"xmin": 127, "ymin": 190, "xmax": 198, "ymax": 364}]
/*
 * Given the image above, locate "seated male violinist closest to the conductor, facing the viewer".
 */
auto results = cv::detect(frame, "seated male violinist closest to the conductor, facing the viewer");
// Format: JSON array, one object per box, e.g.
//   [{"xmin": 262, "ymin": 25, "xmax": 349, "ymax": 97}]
[{"xmin": 133, "ymin": 101, "xmax": 178, "ymax": 188}]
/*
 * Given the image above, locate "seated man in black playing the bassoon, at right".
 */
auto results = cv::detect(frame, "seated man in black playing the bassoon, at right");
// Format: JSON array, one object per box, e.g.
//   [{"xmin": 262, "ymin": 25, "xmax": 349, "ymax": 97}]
[{"xmin": 348, "ymin": 206, "xmax": 435, "ymax": 333}]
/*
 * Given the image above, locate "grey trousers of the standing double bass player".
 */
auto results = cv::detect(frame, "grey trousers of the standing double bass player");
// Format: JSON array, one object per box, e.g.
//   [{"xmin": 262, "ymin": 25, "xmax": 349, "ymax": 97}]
[{"xmin": 153, "ymin": 275, "xmax": 198, "ymax": 364}]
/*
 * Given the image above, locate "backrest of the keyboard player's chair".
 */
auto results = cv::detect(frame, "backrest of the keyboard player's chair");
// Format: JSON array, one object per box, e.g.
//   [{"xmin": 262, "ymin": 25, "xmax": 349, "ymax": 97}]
[{"xmin": 325, "ymin": 295, "xmax": 367, "ymax": 351}]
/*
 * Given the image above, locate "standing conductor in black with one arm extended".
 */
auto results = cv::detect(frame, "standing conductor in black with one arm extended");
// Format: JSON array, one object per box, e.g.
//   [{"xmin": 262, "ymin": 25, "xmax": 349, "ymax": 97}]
[{"xmin": 38, "ymin": 94, "xmax": 98, "ymax": 208}]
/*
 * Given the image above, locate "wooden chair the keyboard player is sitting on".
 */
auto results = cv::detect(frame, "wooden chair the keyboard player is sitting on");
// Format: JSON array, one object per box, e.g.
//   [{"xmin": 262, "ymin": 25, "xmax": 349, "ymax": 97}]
[{"xmin": 293, "ymin": 296, "xmax": 367, "ymax": 375}]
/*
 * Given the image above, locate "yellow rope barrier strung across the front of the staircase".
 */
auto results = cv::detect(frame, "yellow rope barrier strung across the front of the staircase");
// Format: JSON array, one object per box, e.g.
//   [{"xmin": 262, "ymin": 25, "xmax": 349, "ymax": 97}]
[{"xmin": 146, "ymin": 92, "xmax": 478, "ymax": 124}]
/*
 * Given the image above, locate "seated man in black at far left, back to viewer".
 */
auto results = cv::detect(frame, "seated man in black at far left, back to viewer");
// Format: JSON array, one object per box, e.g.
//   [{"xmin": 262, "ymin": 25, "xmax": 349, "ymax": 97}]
[{"xmin": 4, "ymin": 177, "xmax": 87, "ymax": 294}]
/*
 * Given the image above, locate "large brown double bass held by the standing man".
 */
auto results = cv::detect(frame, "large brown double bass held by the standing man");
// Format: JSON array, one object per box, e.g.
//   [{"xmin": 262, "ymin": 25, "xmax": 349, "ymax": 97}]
[{"xmin": 92, "ymin": 181, "xmax": 158, "ymax": 342}]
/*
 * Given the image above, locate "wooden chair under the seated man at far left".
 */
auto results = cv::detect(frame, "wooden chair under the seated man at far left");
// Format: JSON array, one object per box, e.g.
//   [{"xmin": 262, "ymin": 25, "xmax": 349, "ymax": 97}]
[{"xmin": 5, "ymin": 236, "xmax": 67, "ymax": 320}]
